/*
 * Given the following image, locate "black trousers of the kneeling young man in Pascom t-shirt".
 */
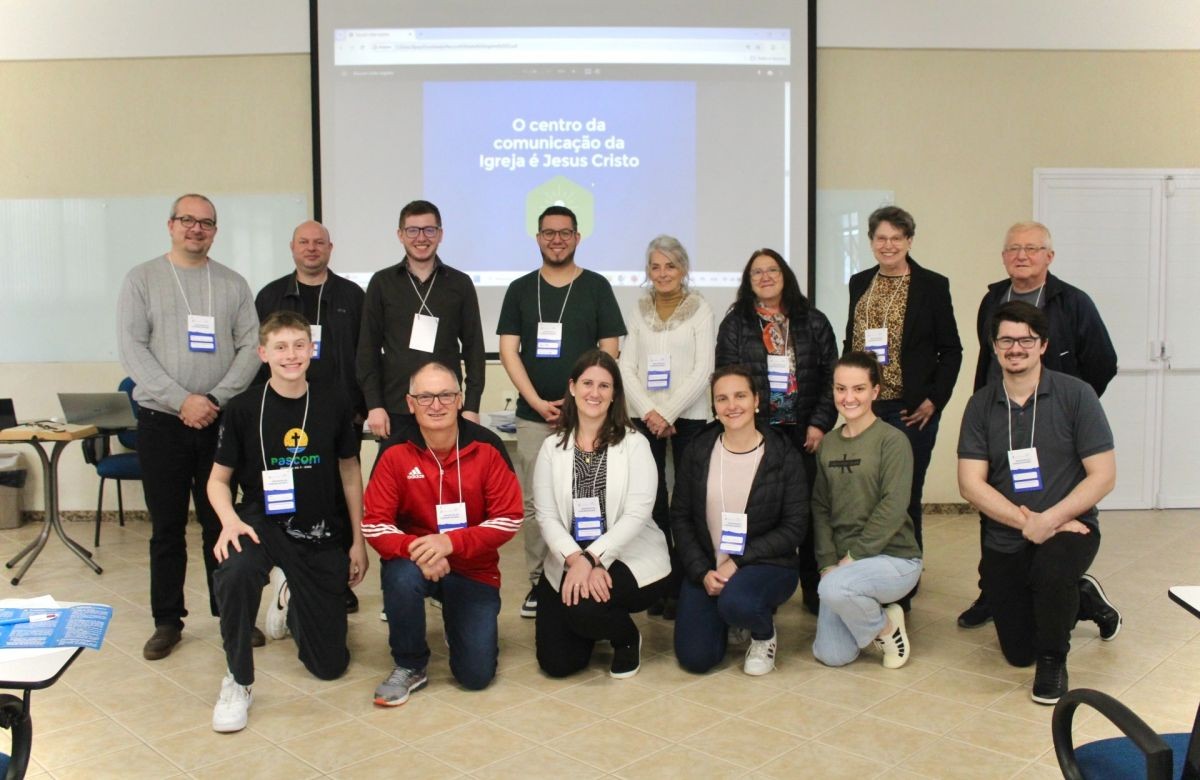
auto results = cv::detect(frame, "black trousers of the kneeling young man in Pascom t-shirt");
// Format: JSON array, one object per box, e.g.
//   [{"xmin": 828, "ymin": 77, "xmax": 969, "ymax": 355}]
[{"xmin": 212, "ymin": 515, "xmax": 350, "ymax": 685}]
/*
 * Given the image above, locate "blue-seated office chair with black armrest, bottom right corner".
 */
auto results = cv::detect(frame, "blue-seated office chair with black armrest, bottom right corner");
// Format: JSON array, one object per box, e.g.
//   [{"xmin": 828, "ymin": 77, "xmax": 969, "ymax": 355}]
[{"xmin": 1050, "ymin": 688, "xmax": 1200, "ymax": 780}]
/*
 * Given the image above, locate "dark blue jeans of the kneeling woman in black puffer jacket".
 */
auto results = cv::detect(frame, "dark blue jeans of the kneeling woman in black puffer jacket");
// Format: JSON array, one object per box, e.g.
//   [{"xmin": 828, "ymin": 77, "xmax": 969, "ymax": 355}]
[{"xmin": 674, "ymin": 564, "xmax": 800, "ymax": 674}]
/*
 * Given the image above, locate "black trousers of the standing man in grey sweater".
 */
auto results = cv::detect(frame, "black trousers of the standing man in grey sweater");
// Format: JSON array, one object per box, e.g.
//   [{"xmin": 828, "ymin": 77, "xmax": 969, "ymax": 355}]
[{"xmin": 138, "ymin": 407, "xmax": 221, "ymax": 628}]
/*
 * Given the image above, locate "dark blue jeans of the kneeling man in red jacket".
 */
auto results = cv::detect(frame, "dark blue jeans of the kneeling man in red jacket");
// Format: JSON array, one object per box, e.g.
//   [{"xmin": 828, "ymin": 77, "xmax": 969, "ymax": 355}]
[{"xmin": 379, "ymin": 558, "xmax": 500, "ymax": 690}]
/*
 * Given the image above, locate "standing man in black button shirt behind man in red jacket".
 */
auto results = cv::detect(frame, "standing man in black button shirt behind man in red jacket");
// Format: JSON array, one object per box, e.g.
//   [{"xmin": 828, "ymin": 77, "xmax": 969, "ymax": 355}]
[{"xmin": 358, "ymin": 200, "xmax": 484, "ymax": 462}]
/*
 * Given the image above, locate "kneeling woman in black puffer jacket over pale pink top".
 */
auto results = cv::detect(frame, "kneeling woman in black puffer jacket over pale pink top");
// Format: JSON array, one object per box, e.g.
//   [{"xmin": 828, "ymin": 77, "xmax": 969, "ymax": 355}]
[{"xmin": 671, "ymin": 366, "xmax": 809, "ymax": 674}]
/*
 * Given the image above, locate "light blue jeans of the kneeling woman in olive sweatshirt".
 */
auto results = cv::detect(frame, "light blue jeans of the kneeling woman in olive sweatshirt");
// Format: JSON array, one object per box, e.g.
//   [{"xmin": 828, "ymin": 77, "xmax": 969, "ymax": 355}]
[{"xmin": 812, "ymin": 556, "xmax": 922, "ymax": 666}]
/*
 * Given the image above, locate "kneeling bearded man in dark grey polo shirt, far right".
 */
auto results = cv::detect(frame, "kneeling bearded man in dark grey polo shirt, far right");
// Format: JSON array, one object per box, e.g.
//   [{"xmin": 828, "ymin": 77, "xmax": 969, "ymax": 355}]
[{"xmin": 959, "ymin": 301, "xmax": 1121, "ymax": 704}]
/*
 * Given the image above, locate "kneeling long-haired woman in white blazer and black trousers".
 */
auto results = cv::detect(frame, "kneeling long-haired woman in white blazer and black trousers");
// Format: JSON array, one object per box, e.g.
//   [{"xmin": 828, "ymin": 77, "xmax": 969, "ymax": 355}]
[{"xmin": 533, "ymin": 349, "xmax": 671, "ymax": 678}]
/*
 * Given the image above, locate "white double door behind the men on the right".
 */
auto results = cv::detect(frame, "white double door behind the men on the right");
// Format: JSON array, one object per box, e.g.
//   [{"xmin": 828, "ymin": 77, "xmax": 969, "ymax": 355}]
[{"xmin": 1034, "ymin": 170, "xmax": 1200, "ymax": 509}]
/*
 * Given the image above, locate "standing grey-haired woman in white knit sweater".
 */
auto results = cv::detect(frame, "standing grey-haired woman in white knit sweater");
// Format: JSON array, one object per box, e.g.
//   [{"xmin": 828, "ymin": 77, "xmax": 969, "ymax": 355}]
[{"xmin": 620, "ymin": 235, "xmax": 715, "ymax": 619}]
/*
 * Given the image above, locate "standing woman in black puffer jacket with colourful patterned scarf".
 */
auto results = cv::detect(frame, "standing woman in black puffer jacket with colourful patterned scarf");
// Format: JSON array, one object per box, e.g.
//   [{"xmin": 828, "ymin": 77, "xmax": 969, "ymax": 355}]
[{"xmin": 716, "ymin": 248, "xmax": 838, "ymax": 614}]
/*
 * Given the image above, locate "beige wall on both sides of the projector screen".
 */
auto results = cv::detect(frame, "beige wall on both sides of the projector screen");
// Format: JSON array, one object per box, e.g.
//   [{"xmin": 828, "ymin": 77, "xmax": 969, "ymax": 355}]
[{"xmin": 0, "ymin": 49, "xmax": 1200, "ymax": 509}]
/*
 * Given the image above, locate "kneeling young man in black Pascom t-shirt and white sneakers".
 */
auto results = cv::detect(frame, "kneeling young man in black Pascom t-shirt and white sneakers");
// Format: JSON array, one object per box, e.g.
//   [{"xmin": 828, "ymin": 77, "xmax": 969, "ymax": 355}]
[{"xmin": 208, "ymin": 312, "xmax": 367, "ymax": 732}]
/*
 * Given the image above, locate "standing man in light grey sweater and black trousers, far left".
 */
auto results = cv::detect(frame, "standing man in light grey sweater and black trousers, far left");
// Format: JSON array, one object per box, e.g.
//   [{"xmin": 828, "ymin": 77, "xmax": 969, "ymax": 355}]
[{"xmin": 118, "ymin": 194, "xmax": 258, "ymax": 660}]
